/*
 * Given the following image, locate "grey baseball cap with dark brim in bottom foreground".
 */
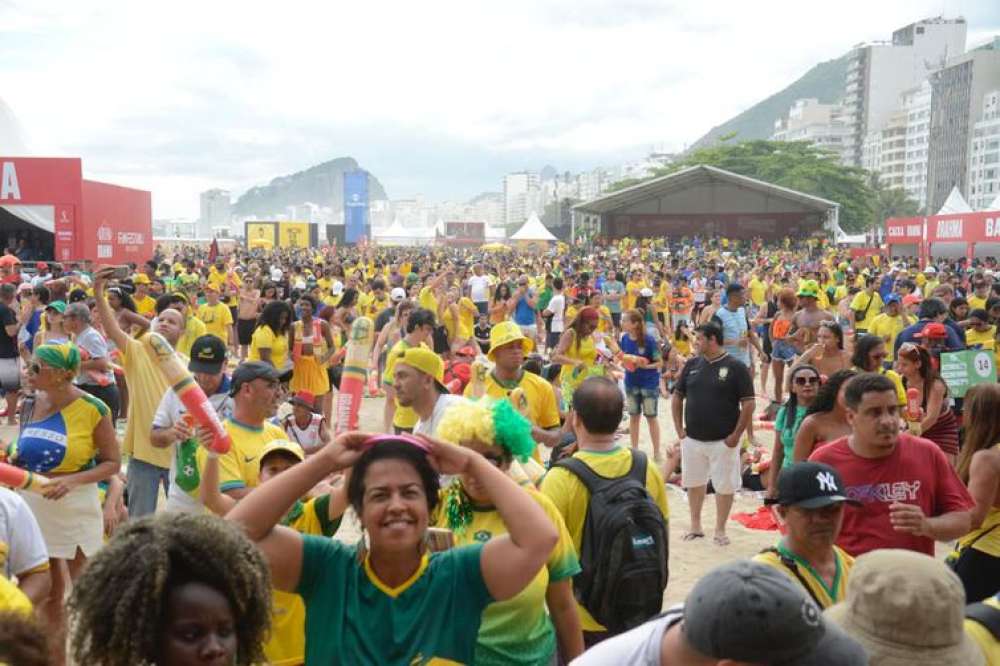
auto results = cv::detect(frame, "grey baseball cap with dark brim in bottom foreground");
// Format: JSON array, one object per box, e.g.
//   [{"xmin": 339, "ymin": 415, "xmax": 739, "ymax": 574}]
[{"xmin": 681, "ymin": 560, "xmax": 868, "ymax": 666}]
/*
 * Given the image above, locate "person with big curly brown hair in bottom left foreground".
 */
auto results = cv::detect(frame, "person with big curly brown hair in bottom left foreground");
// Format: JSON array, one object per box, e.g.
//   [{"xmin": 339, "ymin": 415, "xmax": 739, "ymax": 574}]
[{"xmin": 69, "ymin": 513, "xmax": 271, "ymax": 666}]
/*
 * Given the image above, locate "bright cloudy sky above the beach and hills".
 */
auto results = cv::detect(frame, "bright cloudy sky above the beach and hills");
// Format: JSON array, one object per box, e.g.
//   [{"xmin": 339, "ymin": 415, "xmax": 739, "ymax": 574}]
[{"xmin": 0, "ymin": 0, "xmax": 1000, "ymax": 218}]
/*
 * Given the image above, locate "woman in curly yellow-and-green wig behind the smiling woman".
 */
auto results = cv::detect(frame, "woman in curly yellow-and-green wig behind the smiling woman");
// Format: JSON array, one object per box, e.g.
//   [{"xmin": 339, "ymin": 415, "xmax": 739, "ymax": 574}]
[{"xmin": 436, "ymin": 400, "xmax": 583, "ymax": 666}]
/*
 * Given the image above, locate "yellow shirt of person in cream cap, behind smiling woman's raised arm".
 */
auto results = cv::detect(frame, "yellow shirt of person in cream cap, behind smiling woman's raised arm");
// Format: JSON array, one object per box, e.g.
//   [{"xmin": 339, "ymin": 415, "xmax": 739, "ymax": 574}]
[{"xmin": 264, "ymin": 495, "xmax": 340, "ymax": 666}]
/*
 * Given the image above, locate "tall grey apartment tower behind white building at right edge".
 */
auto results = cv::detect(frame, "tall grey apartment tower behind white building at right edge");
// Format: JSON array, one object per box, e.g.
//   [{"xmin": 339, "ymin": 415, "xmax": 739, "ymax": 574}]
[{"xmin": 927, "ymin": 41, "xmax": 1000, "ymax": 211}]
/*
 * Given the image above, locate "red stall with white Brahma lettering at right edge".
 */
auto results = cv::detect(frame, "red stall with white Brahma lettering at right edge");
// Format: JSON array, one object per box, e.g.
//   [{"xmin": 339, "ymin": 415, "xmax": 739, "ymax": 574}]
[{"xmin": 885, "ymin": 210, "xmax": 1000, "ymax": 262}]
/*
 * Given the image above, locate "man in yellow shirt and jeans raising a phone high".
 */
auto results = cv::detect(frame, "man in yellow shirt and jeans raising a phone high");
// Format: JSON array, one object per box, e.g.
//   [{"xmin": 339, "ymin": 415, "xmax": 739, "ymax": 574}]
[{"xmin": 94, "ymin": 266, "xmax": 184, "ymax": 518}]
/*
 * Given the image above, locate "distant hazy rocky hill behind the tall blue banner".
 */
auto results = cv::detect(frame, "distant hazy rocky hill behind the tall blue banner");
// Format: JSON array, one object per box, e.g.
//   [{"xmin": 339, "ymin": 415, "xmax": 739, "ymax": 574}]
[{"xmin": 233, "ymin": 157, "xmax": 388, "ymax": 217}]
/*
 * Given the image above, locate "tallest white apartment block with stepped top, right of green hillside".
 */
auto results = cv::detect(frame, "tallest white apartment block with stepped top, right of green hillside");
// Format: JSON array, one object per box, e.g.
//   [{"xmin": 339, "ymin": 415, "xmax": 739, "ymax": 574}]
[{"xmin": 843, "ymin": 18, "xmax": 966, "ymax": 166}]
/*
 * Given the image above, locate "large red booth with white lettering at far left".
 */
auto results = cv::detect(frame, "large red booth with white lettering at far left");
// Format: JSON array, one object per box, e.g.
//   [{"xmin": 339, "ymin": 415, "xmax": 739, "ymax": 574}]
[{"xmin": 0, "ymin": 157, "xmax": 153, "ymax": 264}]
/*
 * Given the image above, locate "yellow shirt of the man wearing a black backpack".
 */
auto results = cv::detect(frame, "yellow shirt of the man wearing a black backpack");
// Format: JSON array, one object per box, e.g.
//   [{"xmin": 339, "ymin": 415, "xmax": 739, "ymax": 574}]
[{"xmin": 541, "ymin": 446, "xmax": 670, "ymax": 631}]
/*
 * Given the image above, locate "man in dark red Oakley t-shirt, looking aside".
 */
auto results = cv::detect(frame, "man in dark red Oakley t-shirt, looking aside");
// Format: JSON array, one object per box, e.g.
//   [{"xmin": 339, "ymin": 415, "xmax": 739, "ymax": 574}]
[{"xmin": 809, "ymin": 373, "xmax": 973, "ymax": 557}]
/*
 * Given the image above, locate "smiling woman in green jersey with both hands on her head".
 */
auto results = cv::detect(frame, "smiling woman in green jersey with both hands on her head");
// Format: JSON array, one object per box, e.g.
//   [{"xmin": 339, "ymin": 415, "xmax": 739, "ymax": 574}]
[{"xmin": 226, "ymin": 432, "xmax": 559, "ymax": 666}]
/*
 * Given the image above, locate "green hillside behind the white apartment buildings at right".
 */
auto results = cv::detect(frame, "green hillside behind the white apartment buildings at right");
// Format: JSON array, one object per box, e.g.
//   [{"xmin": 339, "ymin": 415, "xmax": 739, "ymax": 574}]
[{"xmin": 689, "ymin": 54, "xmax": 847, "ymax": 150}]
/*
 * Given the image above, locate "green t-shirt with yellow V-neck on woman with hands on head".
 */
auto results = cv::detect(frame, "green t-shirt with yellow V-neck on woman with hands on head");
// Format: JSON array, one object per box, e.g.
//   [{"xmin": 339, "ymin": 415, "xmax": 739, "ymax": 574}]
[{"xmin": 296, "ymin": 535, "xmax": 493, "ymax": 666}]
